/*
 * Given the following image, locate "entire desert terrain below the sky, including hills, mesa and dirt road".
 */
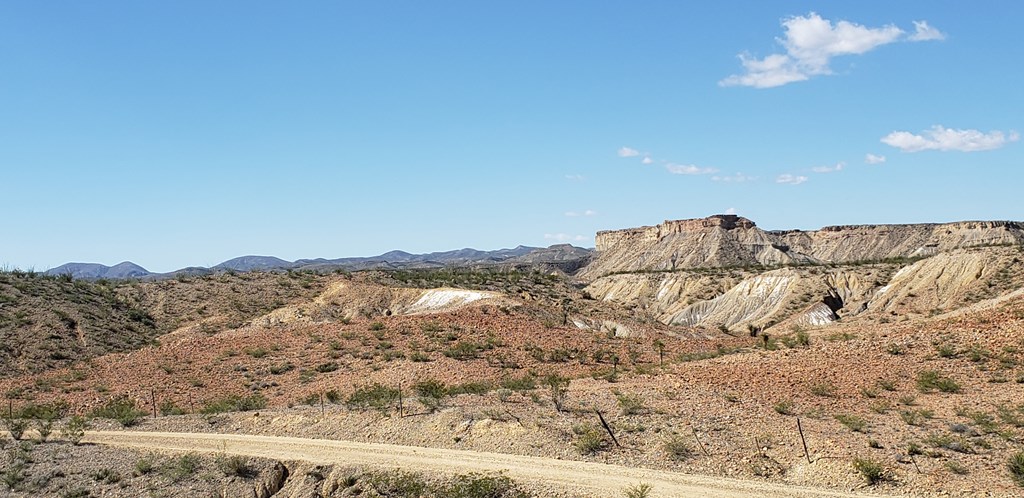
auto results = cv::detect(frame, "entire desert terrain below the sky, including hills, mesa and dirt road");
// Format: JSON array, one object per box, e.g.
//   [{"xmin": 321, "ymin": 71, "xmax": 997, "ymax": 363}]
[{"xmin": 0, "ymin": 215, "xmax": 1024, "ymax": 498}]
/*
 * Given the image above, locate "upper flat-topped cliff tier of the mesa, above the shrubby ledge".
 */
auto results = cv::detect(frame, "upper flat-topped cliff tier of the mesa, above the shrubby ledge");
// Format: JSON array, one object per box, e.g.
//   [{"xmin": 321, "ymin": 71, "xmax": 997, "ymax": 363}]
[{"xmin": 580, "ymin": 214, "xmax": 1024, "ymax": 281}]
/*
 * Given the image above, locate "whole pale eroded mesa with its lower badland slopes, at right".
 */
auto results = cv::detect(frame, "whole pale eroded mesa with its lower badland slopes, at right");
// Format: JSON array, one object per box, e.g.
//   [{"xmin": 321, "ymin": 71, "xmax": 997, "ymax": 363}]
[{"xmin": 579, "ymin": 215, "xmax": 1024, "ymax": 329}]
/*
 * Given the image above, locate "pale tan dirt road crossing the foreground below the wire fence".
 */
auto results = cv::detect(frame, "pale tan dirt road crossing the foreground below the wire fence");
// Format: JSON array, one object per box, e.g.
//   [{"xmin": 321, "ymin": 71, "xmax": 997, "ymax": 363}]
[{"xmin": 84, "ymin": 431, "xmax": 871, "ymax": 498}]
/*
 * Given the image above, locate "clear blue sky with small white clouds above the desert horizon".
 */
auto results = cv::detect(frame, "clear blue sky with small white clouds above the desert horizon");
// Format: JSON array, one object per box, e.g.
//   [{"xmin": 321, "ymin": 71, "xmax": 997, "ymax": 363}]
[{"xmin": 0, "ymin": 0, "xmax": 1024, "ymax": 271}]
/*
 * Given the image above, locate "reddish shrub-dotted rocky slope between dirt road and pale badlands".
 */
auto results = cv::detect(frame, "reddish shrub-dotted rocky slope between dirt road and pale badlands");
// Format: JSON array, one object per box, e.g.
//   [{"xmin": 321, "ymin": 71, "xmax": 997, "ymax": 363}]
[{"xmin": 5, "ymin": 298, "xmax": 1024, "ymax": 496}]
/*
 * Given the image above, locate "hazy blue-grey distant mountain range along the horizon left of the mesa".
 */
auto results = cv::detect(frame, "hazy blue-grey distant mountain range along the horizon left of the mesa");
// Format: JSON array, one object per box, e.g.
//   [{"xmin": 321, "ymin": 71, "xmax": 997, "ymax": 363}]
[{"xmin": 46, "ymin": 244, "xmax": 592, "ymax": 280}]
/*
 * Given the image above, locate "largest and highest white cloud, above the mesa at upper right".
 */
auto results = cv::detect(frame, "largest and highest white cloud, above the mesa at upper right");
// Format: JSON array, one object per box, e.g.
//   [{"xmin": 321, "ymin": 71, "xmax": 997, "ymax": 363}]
[{"xmin": 718, "ymin": 12, "xmax": 944, "ymax": 88}]
